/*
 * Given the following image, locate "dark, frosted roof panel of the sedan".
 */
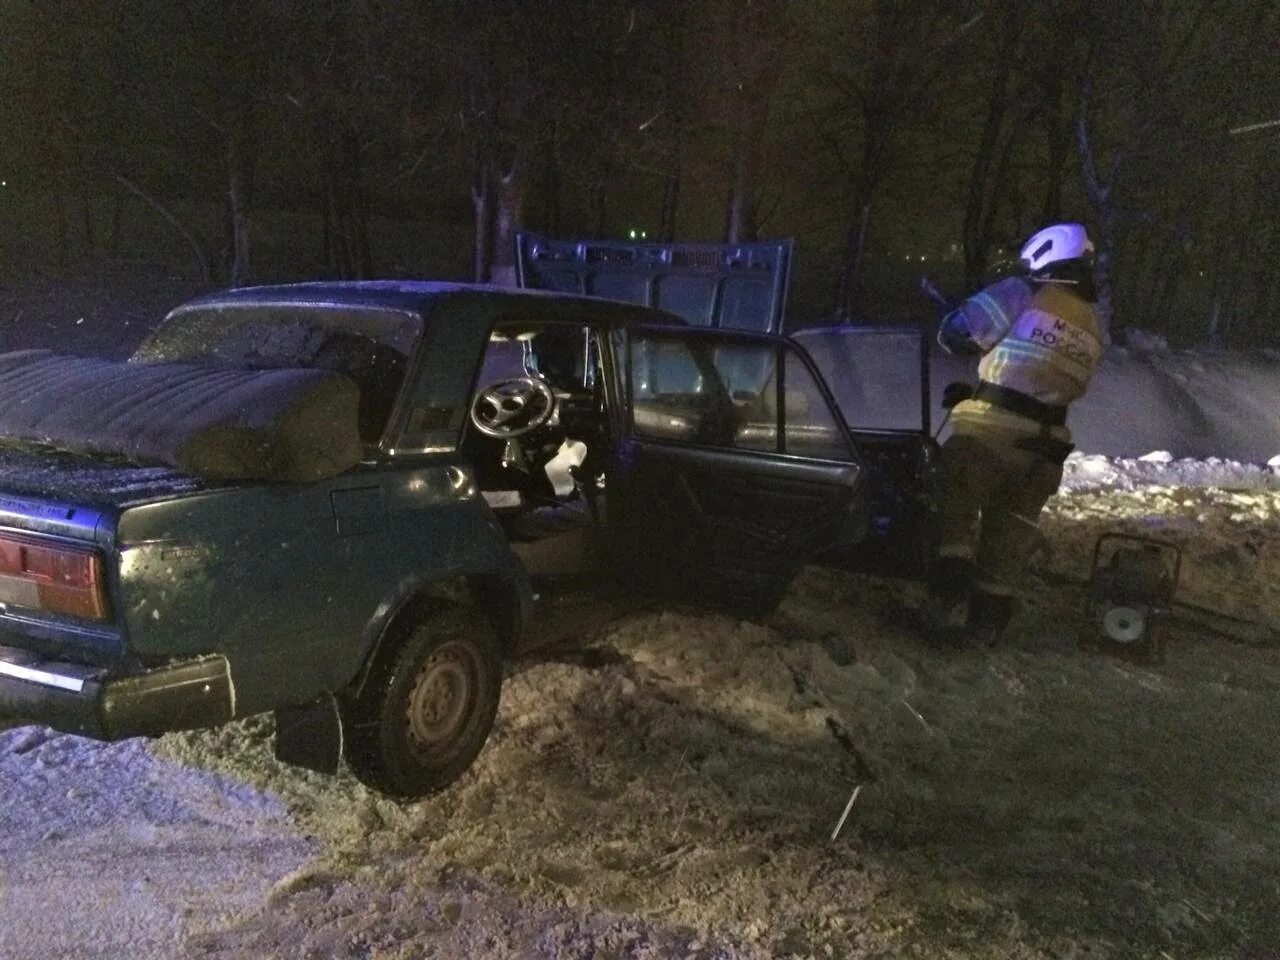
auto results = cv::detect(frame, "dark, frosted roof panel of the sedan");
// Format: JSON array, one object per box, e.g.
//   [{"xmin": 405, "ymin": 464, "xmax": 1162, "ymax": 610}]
[{"xmin": 170, "ymin": 280, "xmax": 684, "ymax": 326}]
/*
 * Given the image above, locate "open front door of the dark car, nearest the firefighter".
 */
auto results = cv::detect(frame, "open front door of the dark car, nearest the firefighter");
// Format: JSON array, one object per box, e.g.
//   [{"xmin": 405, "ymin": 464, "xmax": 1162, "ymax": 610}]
[{"xmin": 795, "ymin": 326, "xmax": 940, "ymax": 577}]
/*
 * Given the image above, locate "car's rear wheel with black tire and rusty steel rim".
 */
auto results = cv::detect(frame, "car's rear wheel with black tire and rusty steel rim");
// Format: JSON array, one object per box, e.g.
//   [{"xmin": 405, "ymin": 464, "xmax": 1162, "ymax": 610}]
[{"xmin": 343, "ymin": 608, "xmax": 502, "ymax": 799}]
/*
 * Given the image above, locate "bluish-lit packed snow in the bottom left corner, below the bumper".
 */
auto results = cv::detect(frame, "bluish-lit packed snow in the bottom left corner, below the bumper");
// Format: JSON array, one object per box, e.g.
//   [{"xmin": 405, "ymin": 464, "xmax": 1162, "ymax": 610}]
[{"xmin": 0, "ymin": 727, "xmax": 317, "ymax": 960}]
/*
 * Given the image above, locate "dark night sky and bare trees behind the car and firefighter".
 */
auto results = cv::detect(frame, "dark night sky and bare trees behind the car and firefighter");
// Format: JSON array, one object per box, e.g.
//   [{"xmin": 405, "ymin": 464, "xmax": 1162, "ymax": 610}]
[{"xmin": 0, "ymin": 0, "xmax": 1280, "ymax": 342}]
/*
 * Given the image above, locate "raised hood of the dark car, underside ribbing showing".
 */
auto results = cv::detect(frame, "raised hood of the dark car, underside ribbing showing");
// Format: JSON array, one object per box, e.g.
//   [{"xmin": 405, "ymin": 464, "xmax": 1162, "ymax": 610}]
[{"xmin": 516, "ymin": 233, "xmax": 791, "ymax": 333}]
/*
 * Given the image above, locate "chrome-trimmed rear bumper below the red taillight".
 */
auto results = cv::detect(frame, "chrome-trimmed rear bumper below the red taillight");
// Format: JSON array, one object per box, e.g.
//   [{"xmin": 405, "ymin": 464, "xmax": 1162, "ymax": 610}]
[{"xmin": 0, "ymin": 646, "xmax": 236, "ymax": 740}]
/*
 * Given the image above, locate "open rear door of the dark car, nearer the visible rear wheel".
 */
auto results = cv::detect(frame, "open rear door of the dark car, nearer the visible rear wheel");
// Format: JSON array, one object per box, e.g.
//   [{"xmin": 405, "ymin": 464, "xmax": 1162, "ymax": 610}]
[{"xmin": 608, "ymin": 326, "xmax": 867, "ymax": 612}]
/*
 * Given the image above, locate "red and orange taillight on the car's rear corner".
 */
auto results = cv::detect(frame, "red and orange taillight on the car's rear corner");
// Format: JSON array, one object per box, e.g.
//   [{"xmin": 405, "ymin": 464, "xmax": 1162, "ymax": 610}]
[{"xmin": 0, "ymin": 532, "xmax": 108, "ymax": 620}]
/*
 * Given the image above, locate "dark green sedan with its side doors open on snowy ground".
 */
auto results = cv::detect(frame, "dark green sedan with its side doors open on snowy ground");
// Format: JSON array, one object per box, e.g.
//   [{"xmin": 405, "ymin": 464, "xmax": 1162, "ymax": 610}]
[{"xmin": 0, "ymin": 282, "xmax": 929, "ymax": 796}]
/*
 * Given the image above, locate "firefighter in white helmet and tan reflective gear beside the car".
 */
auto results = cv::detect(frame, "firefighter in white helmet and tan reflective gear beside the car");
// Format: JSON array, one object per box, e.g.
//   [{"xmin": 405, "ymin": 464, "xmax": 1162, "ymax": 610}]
[{"xmin": 929, "ymin": 223, "xmax": 1102, "ymax": 643}]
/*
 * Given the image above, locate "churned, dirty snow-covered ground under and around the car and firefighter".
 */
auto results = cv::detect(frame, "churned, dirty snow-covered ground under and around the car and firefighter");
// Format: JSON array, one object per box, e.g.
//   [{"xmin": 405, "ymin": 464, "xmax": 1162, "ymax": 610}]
[{"xmin": 0, "ymin": 456, "xmax": 1280, "ymax": 960}]
